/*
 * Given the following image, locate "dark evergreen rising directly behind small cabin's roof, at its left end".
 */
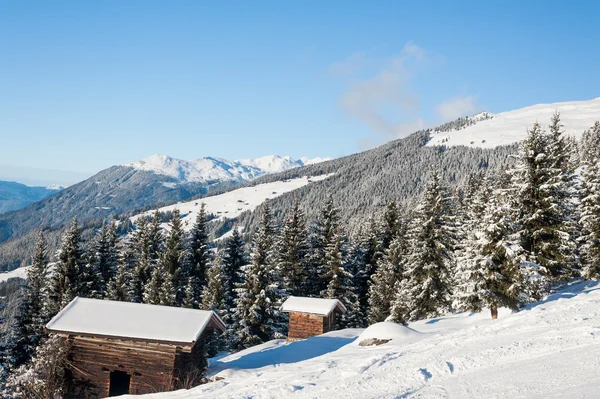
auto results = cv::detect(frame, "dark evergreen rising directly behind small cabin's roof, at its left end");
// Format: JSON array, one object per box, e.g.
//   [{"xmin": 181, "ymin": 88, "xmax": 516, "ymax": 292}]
[{"xmin": 275, "ymin": 201, "xmax": 309, "ymax": 296}]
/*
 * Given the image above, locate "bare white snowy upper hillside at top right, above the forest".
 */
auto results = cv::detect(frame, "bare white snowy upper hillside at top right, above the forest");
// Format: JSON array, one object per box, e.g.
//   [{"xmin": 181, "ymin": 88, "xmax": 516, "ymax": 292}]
[{"xmin": 428, "ymin": 98, "xmax": 600, "ymax": 148}]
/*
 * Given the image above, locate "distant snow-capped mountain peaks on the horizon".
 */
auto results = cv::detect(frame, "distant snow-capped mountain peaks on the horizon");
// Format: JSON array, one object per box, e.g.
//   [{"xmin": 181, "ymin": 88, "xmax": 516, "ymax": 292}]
[{"xmin": 124, "ymin": 154, "xmax": 328, "ymax": 183}]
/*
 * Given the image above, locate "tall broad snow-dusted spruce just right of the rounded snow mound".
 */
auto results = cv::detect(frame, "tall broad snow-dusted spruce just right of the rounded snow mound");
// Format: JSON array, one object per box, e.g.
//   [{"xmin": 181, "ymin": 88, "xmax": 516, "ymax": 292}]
[{"xmin": 395, "ymin": 171, "xmax": 456, "ymax": 321}]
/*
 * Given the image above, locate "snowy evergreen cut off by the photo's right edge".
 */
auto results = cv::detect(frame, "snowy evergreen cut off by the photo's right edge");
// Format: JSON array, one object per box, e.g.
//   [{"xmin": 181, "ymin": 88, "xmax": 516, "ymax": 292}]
[{"xmin": 580, "ymin": 122, "xmax": 600, "ymax": 280}]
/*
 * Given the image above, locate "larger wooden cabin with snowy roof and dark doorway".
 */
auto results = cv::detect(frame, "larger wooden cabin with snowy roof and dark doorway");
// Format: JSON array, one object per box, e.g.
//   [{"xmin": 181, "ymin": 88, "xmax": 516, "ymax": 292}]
[{"xmin": 46, "ymin": 298, "xmax": 225, "ymax": 398}]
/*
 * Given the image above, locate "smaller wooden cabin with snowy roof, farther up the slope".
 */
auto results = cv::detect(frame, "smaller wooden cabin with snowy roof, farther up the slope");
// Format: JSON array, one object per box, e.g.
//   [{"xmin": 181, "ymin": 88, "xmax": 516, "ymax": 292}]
[{"xmin": 281, "ymin": 296, "xmax": 346, "ymax": 341}]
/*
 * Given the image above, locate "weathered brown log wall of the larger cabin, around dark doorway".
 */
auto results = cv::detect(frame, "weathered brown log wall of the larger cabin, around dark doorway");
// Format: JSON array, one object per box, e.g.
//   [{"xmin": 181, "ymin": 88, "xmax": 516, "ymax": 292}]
[{"xmin": 63, "ymin": 336, "xmax": 195, "ymax": 398}]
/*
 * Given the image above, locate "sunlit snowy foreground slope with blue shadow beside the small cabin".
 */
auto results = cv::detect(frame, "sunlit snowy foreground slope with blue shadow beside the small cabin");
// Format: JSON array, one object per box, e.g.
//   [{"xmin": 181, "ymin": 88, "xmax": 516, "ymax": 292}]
[{"xmin": 124, "ymin": 282, "xmax": 600, "ymax": 399}]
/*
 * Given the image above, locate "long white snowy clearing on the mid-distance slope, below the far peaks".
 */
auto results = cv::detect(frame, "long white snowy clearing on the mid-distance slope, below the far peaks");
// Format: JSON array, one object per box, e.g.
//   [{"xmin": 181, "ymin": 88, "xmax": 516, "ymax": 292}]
[{"xmin": 131, "ymin": 174, "xmax": 332, "ymax": 230}]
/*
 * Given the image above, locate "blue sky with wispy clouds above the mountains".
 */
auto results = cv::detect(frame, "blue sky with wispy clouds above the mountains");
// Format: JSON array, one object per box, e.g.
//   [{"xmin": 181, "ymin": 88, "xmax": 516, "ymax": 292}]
[{"xmin": 0, "ymin": 0, "xmax": 600, "ymax": 184}]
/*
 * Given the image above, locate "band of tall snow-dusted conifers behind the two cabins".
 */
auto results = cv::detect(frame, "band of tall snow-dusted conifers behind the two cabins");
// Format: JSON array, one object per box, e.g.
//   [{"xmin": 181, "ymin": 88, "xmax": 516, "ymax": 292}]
[{"xmin": 0, "ymin": 114, "xmax": 600, "ymax": 397}]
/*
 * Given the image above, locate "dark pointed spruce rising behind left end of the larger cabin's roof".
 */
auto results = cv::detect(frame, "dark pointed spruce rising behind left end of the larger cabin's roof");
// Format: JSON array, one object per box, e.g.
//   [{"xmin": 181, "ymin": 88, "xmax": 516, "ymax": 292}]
[{"xmin": 47, "ymin": 219, "xmax": 83, "ymax": 316}]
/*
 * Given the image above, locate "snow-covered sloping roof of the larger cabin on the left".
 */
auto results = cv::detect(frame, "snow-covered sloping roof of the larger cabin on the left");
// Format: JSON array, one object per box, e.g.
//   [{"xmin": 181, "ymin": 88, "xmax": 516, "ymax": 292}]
[{"xmin": 46, "ymin": 297, "xmax": 225, "ymax": 344}]
